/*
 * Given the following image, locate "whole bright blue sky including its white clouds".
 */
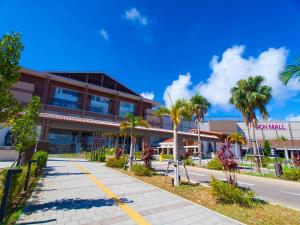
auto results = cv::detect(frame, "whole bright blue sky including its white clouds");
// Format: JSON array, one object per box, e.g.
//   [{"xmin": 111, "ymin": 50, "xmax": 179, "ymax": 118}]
[{"xmin": 0, "ymin": 0, "xmax": 300, "ymax": 119}]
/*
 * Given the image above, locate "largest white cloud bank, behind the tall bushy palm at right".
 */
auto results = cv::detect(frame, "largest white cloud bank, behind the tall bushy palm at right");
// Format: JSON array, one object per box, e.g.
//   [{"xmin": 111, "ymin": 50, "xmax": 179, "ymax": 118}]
[{"xmin": 164, "ymin": 45, "xmax": 299, "ymax": 110}]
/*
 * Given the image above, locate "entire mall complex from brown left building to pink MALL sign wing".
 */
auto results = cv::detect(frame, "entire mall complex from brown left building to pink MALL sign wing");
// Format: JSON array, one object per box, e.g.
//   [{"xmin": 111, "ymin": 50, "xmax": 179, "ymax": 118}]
[{"xmin": 0, "ymin": 68, "xmax": 300, "ymax": 160}]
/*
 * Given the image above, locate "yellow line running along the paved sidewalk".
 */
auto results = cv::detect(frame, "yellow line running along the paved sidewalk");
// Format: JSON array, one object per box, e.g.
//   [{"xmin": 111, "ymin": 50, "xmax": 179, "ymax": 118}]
[{"xmin": 76, "ymin": 163, "xmax": 150, "ymax": 225}]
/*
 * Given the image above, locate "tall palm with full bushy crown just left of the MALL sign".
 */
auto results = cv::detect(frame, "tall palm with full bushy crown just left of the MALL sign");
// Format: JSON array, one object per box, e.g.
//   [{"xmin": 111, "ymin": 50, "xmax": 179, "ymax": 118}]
[{"xmin": 229, "ymin": 76, "xmax": 272, "ymax": 173}]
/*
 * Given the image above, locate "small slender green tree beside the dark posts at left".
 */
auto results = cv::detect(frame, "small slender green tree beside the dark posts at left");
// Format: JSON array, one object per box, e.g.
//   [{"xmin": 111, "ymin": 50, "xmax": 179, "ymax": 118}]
[{"xmin": 9, "ymin": 96, "xmax": 41, "ymax": 165}]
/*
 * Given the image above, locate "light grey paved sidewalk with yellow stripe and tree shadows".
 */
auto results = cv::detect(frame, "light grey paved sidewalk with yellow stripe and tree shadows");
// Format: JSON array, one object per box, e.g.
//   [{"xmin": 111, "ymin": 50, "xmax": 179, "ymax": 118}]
[{"xmin": 17, "ymin": 159, "xmax": 239, "ymax": 225}]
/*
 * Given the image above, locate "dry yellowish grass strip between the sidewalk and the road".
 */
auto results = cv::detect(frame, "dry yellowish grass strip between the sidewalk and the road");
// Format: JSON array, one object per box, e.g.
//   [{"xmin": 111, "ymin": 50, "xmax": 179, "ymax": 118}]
[{"xmin": 119, "ymin": 170, "xmax": 300, "ymax": 225}]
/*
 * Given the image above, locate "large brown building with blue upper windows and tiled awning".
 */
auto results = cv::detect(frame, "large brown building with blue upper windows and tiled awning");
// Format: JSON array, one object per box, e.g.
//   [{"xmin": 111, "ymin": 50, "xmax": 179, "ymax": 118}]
[{"xmin": 4, "ymin": 68, "xmax": 223, "ymax": 153}]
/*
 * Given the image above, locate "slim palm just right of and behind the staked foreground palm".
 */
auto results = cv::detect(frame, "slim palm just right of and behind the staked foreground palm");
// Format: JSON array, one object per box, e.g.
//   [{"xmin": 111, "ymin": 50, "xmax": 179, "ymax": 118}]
[{"xmin": 190, "ymin": 93, "xmax": 211, "ymax": 166}]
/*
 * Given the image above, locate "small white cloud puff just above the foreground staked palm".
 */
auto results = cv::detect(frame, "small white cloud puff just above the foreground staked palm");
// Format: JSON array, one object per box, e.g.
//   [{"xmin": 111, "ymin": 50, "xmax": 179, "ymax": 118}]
[{"xmin": 163, "ymin": 73, "xmax": 193, "ymax": 106}]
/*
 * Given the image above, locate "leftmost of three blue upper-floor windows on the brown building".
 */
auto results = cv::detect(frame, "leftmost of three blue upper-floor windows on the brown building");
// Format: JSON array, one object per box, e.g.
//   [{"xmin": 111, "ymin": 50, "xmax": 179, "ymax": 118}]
[{"xmin": 52, "ymin": 87, "xmax": 79, "ymax": 109}]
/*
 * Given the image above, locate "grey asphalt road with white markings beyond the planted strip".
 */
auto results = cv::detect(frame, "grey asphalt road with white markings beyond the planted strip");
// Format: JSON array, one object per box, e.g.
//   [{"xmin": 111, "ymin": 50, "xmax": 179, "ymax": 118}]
[{"xmin": 153, "ymin": 162, "xmax": 300, "ymax": 211}]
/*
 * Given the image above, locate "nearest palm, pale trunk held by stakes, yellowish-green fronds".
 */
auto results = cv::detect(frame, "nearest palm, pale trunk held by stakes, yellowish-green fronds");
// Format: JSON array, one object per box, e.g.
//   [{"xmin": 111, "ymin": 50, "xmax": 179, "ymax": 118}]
[{"xmin": 154, "ymin": 99, "xmax": 193, "ymax": 186}]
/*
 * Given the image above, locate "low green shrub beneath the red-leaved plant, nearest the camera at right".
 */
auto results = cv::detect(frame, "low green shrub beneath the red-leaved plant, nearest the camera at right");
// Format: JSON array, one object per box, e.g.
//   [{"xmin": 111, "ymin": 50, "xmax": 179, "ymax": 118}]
[{"xmin": 210, "ymin": 177, "xmax": 255, "ymax": 207}]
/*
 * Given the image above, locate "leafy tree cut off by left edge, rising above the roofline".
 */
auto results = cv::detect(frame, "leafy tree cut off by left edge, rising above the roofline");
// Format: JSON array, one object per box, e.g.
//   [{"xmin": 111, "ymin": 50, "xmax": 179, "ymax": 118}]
[{"xmin": 0, "ymin": 32, "xmax": 23, "ymax": 122}]
